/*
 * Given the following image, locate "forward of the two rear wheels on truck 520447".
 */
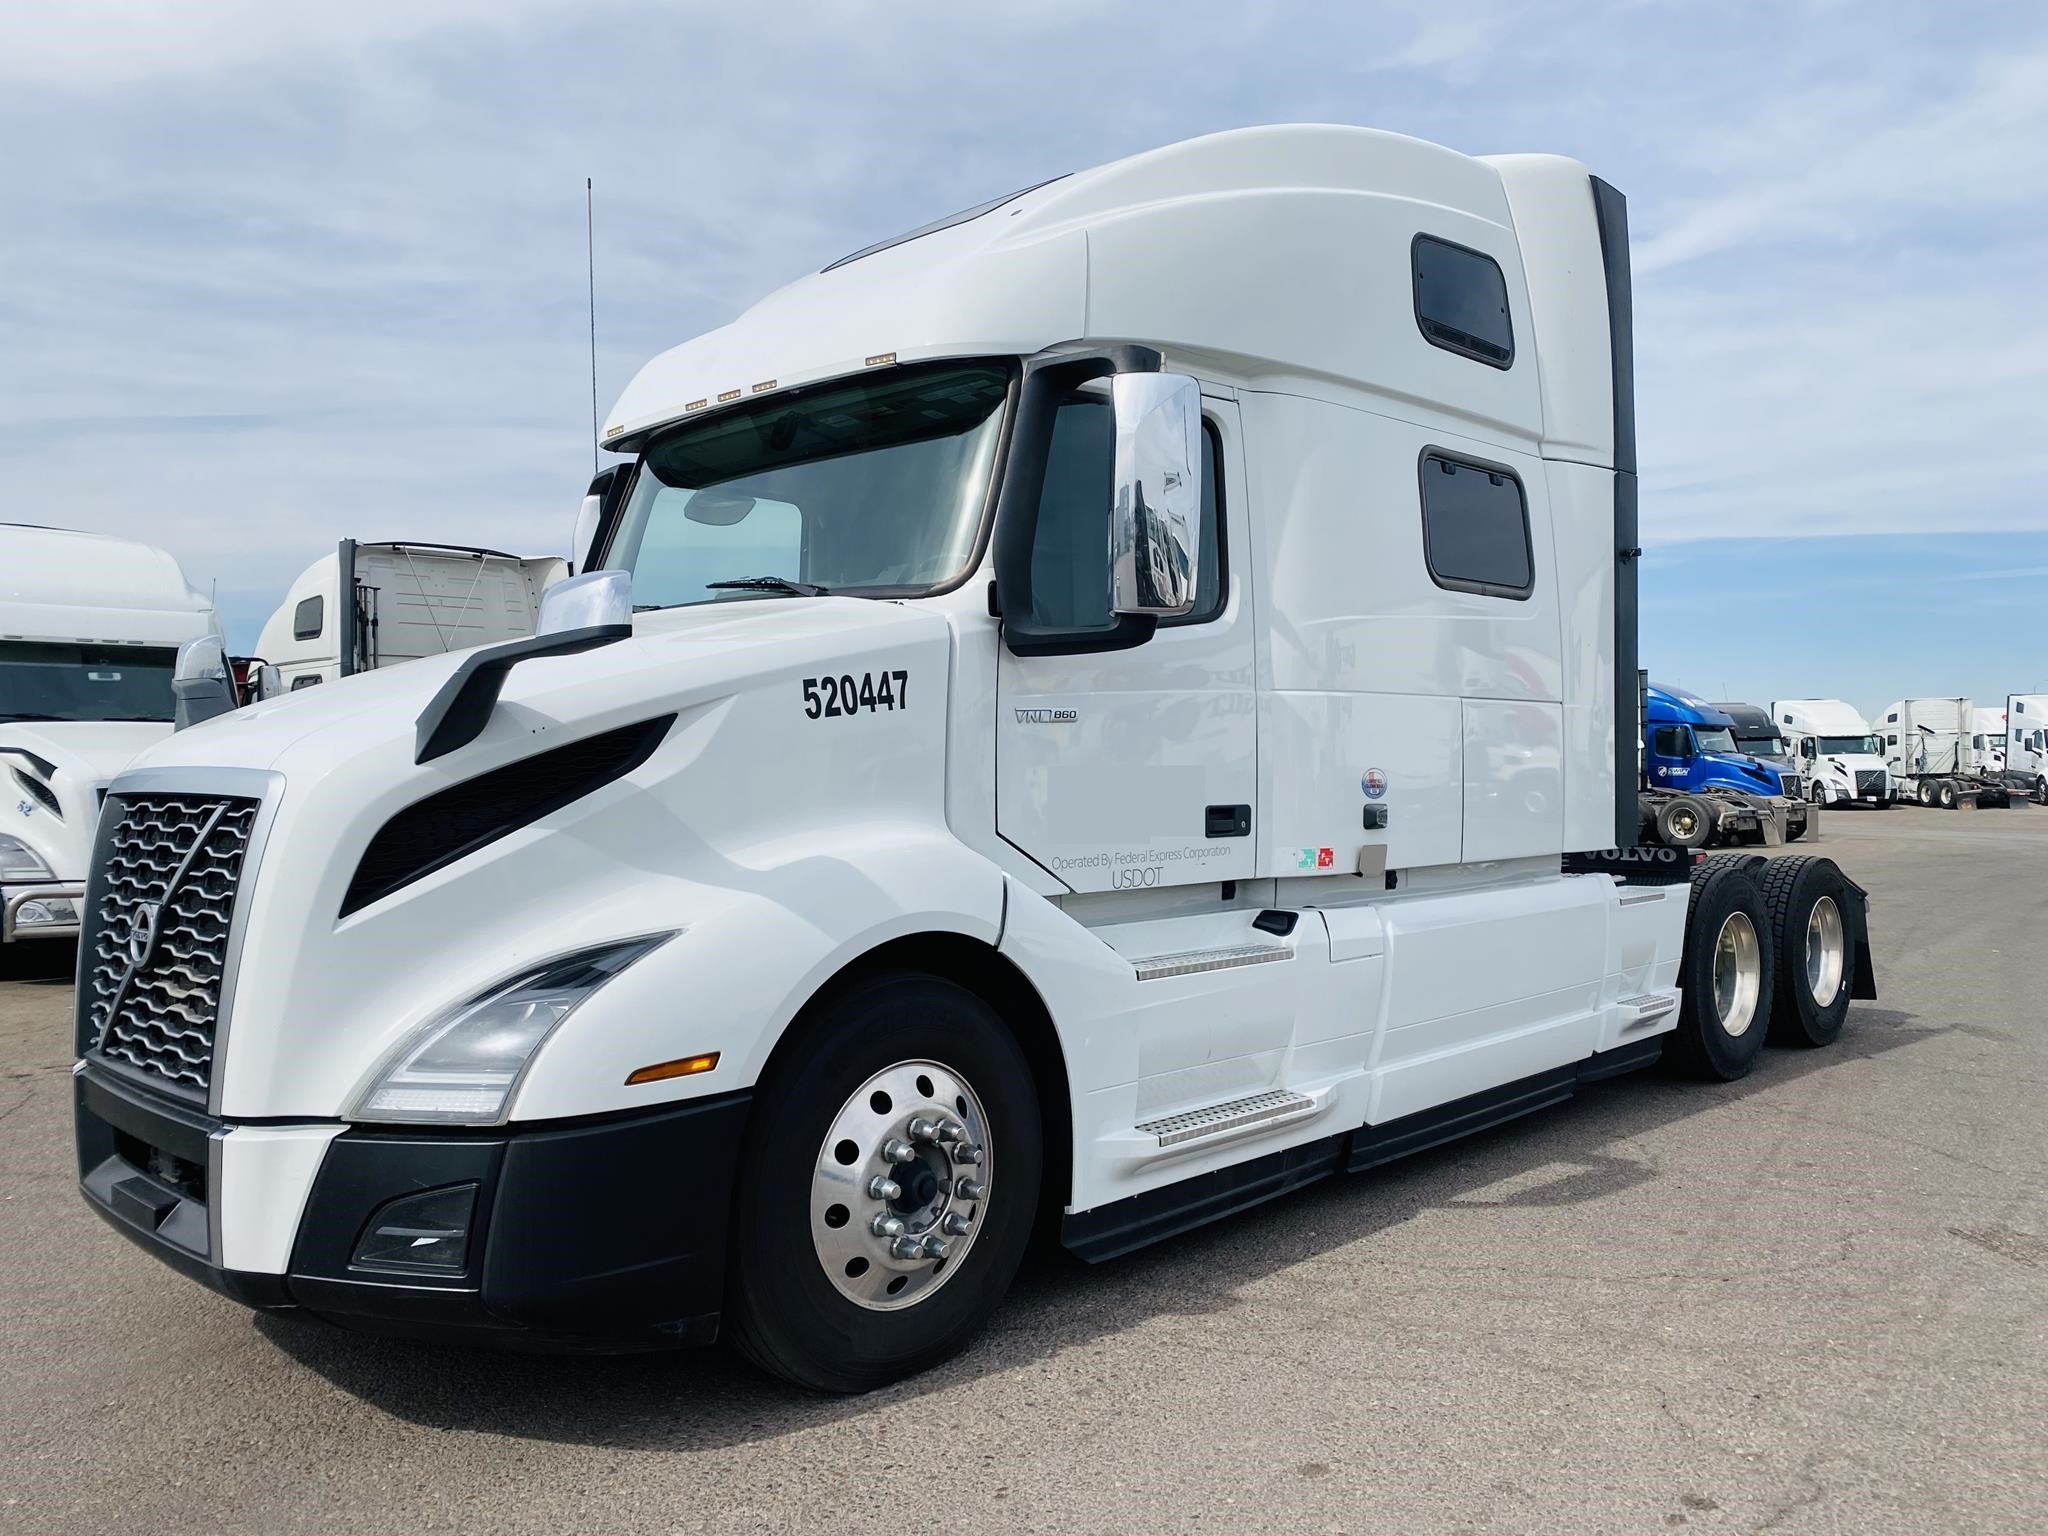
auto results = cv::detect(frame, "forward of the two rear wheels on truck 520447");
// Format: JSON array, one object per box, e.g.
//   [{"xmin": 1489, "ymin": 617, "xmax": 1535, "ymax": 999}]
[{"xmin": 1665, "ymin": 860, "xmax": 1776, "ymax": 1081}]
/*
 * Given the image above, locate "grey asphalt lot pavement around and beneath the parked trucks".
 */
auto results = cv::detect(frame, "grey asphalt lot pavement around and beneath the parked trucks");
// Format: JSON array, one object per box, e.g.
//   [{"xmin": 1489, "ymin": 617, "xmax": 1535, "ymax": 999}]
[{"xmin": 0, "ymin": 807, "xmax": 2048, "ymax": 1536}]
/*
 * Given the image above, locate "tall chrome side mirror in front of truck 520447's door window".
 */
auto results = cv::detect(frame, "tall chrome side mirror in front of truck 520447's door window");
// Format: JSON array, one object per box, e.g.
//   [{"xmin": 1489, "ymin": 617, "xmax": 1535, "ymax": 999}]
[{"xmin": 1110, "ymin": 373, "xmax": 1202, "ymax": 618}]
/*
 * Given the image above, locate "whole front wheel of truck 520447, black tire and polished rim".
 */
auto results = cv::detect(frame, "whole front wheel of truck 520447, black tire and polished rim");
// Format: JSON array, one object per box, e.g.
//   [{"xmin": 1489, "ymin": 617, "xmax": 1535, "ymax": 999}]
[{"xmin": 729, "ymin": 973, "xmax": 1042, "ymax": 1393}]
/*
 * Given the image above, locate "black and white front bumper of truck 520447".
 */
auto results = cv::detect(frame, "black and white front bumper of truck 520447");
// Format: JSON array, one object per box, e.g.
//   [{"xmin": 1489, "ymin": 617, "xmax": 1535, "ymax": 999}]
[{"xmin": 74, "ymin": 1063, "xmax": 752, "ymax": 1352}]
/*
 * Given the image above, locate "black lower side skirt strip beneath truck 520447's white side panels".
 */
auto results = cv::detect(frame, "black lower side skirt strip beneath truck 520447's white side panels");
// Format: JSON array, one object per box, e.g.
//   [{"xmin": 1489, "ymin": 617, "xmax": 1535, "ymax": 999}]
[{"xmin": 1059, "ymin": 1034, "xmax": 1663, "ymax": 1264}]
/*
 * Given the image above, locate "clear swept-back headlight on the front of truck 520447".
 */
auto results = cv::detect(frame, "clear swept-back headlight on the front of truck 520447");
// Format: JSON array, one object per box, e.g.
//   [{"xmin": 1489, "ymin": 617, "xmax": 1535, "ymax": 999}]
[{"xmin": 348, "ymin": 934, "xmax": 672, "ymax": 1124}]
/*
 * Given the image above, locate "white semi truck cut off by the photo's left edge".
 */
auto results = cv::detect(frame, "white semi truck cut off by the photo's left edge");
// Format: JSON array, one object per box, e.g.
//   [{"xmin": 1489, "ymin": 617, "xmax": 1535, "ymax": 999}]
[{"xmin": 0, "ymin": 522, "xmax": 221, "ymax": 961}]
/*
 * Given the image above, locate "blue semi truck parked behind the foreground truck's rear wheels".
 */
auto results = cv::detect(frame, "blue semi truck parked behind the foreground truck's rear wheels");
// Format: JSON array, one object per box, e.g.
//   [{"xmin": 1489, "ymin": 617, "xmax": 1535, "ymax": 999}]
[{"xmin": 1638, "ymin": 684, "xmax": 1810, "ymax": 848}]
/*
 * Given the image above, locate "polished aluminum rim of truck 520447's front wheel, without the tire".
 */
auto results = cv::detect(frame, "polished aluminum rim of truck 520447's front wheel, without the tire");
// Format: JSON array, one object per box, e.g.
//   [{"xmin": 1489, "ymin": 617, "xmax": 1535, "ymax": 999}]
[{"xmin": 811, "ymin": 1061, "xmax": 993, "ymax": 1313}]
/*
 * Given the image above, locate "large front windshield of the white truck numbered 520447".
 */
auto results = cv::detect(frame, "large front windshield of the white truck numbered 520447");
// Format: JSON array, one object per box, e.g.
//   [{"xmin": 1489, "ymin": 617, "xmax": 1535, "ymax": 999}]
[{"xmin": 604, "ymin": 362, "xmax": 1010, "ymax": 608}]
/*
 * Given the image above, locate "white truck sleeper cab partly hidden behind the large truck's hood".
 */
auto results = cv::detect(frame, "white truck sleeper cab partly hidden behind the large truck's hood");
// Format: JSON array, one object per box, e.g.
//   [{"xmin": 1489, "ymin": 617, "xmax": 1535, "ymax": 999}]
[{"xmin": 256, "ymin": 539, "xmax": 569, "ymax": 690}]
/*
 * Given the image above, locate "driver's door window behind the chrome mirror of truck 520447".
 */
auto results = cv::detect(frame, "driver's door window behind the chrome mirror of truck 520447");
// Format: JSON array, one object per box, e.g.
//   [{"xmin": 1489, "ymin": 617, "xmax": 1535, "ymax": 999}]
[{"xmin": 1030, "ymin": 395, "xmax": 1229, "ymax": 629}]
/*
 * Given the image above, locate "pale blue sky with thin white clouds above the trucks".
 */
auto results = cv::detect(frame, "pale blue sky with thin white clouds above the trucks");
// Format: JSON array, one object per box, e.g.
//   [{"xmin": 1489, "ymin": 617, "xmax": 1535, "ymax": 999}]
[{"xmin": 0, "ymin": 0, "xmax": 2048, "ymax": 707}]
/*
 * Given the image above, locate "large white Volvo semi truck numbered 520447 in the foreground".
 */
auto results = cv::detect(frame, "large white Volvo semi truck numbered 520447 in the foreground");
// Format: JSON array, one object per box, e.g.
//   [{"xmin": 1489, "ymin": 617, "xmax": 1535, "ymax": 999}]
[{"xmin": 78, "ymin": 127, "xmax": 1874, "ymax": 1391}]
